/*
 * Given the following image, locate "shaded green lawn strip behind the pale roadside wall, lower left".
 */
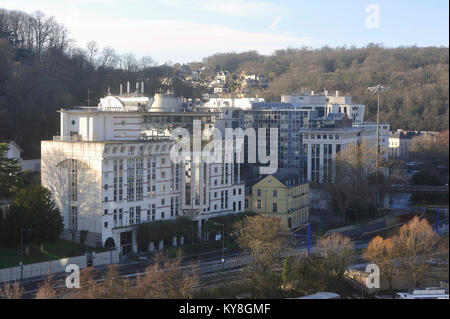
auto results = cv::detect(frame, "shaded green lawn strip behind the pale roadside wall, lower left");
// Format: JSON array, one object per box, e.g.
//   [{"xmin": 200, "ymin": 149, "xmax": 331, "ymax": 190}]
[{"xmin": 0, "ymin": 239, "xmax": 104, "ymax": 268}]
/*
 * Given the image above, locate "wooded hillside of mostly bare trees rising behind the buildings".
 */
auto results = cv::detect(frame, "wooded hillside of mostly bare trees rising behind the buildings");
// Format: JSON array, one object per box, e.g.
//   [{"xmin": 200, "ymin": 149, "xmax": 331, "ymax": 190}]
[{"xmin": 0, "ymin": 9, "xmax": 449, "ymax": 158}]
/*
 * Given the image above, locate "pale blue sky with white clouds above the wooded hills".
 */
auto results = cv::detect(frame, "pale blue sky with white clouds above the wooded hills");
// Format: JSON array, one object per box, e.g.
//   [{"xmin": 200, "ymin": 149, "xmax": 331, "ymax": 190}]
[{"xmin": 0, "ymin": 0, "xmax": 449, "ymax": 63}]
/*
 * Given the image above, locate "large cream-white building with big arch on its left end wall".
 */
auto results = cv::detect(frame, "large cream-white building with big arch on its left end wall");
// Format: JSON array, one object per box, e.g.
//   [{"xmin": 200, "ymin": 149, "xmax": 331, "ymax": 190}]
[{"xmin": 41, "ymin": 90, "xmax": 245, "ymax": 253}]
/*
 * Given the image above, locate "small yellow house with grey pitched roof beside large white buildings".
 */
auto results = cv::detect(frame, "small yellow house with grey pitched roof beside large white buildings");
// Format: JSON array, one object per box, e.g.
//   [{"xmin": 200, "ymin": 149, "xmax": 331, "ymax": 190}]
[{"xmin": 245, "ymin": 169, "xmax": 309, "ymax": 228}]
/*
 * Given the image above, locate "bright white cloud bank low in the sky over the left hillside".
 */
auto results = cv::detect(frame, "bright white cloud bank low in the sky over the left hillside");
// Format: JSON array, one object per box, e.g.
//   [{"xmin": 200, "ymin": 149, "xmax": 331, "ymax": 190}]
[{"xmin": 0, "ymin": 0, "xmax": 321, "ymax": 63}]
